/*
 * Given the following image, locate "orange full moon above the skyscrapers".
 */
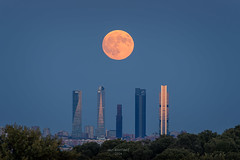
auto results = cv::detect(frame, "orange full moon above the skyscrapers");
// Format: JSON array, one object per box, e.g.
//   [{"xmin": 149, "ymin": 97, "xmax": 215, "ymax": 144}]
[{"xmin": 102, "ymin": 30, "xmax": 134, "ymax": 60}]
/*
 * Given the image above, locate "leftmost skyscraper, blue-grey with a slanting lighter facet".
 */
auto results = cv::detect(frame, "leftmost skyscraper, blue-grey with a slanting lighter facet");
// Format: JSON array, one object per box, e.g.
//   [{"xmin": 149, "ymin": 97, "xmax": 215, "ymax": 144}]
[{"xmin": 72, "ymin": 90, "xmax": 82, "ymax": 138}]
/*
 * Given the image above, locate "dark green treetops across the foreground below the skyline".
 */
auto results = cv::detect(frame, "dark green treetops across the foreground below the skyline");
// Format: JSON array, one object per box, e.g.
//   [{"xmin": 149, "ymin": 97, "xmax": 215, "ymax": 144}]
[{"xmin": 0, "ymin": 125, "xmax": 240, "ymax": 160}]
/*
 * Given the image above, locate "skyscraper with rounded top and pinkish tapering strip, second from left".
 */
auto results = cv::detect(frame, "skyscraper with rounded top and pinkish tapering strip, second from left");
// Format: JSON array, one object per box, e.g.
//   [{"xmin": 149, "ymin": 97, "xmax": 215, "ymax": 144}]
[{"xmin": 95, "ymin": 86, "xmax": 105, "ymax": 138}]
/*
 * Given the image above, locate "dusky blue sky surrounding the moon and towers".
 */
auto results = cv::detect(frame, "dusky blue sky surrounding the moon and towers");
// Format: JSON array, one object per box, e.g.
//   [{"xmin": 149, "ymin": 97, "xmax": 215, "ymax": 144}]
[{"xmin": 0, "ymin": 0, "xmax": 240, "ymax": 134}]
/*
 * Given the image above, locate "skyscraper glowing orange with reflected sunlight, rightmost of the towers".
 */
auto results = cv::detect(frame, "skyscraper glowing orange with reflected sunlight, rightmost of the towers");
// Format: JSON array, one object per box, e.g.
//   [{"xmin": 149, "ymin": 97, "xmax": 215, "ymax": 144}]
[{"xmin": 159, "ymin": 85, "xmax": 169, "ymax": 135}]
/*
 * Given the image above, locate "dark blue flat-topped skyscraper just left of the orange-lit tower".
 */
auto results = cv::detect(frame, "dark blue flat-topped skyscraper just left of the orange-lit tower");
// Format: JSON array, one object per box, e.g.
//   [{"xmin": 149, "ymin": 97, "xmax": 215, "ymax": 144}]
[{"xmin": 135, "ymin": 88, "xmax": 146, "ymax": 138}]
